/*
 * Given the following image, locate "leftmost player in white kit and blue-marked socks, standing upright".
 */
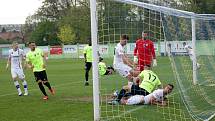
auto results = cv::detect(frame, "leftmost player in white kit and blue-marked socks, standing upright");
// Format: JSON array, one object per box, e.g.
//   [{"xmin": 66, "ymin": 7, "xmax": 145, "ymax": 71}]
[{"xmin": 6, "ymin": 42, "xmax": 28, "ymax": 96}]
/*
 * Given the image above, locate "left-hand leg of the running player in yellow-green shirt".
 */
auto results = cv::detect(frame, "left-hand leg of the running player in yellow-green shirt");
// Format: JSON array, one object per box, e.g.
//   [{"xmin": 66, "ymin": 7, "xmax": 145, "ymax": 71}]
[{"xmin": 34, "ymin": 72, "xmax": 48, "ymax": 100}]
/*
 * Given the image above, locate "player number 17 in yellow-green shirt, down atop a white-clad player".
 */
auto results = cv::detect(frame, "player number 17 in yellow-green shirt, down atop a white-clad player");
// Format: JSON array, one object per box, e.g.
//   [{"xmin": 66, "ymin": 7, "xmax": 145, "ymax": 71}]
[{"xmin": 109, "ymin": 65, "xmax": 161, "ymax": 105}]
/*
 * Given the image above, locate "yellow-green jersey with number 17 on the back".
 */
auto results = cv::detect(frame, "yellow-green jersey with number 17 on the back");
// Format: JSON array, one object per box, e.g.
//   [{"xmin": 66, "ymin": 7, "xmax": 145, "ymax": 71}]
[{"xmin": 139, "ymin": 70, "xmax": 161, "ymax": 93}]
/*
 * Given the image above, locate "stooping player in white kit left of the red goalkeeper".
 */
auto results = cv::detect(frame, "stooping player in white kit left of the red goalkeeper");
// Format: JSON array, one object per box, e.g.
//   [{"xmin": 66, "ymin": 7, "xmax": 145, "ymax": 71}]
[{"xmin": 113, "ymin": 35, "xmax": 140, "ymax": 85}]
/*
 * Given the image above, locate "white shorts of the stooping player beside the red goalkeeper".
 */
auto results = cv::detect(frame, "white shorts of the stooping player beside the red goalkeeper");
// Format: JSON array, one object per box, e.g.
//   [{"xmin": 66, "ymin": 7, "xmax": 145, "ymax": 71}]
[{"xmin": 114, "ymin": 63, "xmax": 132, "ymax": 77}]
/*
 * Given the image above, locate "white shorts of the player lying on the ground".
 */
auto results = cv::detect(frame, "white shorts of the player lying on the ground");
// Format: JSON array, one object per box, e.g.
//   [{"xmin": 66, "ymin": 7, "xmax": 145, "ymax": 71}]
[{"xmin": 126, "ymin": 95, "xmax": 144, "ymax": 105}]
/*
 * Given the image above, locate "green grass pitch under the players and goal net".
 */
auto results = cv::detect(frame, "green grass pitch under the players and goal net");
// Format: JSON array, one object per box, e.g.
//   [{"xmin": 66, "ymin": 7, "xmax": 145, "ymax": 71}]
[{"xmin": 0, "ymin": 57, "xmax": 193, "ymax": 121}]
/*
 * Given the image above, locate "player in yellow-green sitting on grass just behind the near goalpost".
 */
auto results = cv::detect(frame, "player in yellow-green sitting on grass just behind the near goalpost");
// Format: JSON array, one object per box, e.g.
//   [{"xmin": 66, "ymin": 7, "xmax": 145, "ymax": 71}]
[{"xmin": 98, "ymin": 57, "xmax": 114, "ymax": 76}]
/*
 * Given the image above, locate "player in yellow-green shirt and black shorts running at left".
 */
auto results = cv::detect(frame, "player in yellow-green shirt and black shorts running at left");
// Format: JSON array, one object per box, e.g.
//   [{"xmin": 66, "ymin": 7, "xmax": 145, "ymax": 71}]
[{"xmin": 26, "ymin": 42, "xmax": 55, "ymax": 100}]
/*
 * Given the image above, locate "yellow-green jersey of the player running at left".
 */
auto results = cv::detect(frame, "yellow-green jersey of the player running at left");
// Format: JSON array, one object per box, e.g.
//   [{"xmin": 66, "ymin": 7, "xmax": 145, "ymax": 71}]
[{"xmin": 26, "ymin": 48, "xmax": 45, "ymax": 72}]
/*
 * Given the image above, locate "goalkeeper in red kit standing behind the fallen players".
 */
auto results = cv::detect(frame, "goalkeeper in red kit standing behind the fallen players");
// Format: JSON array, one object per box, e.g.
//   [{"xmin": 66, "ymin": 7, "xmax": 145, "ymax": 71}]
[{"xmin": 134, "ymin": 32, "xmax": 157, "ymax": 71}]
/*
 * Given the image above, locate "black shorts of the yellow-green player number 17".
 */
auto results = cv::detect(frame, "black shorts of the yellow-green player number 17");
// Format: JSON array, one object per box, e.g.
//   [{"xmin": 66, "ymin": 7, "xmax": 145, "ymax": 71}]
[{"xmin": 131, "ymin": 84, "xmax": 149, "ymax": 96}]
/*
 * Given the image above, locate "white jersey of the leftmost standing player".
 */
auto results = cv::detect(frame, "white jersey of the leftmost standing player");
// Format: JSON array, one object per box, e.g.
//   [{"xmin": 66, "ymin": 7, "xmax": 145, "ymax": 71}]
[{"xmin": 9, "ymin": 48, "xmax": 24, "ymax": 69}]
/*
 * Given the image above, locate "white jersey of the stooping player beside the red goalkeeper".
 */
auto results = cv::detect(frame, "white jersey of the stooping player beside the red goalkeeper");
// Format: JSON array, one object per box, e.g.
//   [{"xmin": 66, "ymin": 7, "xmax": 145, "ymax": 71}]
[{"xmin": 113, "ymin": 43, "xmax": 125, "ymax": 65}]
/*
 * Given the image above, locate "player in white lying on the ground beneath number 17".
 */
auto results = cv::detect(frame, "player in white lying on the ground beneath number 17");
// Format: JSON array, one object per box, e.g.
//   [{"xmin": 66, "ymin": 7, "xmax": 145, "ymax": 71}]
[{"xmin": 121, "ymin": 84, "xmax": 174, "ymax": 106}]
